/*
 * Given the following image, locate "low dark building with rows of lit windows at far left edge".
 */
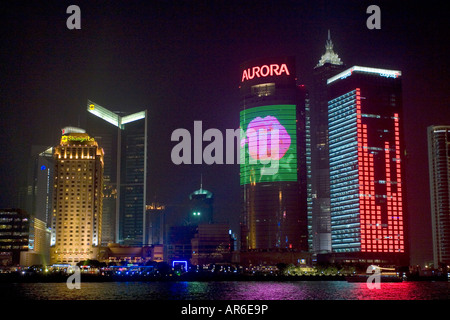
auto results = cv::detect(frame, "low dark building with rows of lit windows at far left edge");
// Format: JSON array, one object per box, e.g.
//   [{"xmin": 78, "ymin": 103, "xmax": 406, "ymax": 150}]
[{"xmin": 0, "ymin": 209, "xmax": 30, "ymax": 266}]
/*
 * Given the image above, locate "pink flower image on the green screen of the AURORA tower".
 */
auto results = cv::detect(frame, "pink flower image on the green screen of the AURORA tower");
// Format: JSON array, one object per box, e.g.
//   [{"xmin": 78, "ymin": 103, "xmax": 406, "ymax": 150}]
[{"xmin": 241, "ymin": 116, "xmax": 291, "ymax": 160}]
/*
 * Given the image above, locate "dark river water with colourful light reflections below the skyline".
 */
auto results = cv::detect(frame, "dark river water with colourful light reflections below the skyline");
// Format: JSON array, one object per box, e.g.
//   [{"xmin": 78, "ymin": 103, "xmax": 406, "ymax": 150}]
[{"xmin": 0, "ymin": 281, "xmax": 450, "ymax": 300}]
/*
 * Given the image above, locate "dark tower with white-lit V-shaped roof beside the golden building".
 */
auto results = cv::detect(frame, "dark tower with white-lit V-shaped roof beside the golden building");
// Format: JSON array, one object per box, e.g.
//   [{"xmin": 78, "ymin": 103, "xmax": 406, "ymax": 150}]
[{"xmin": 87, "ymin": 101, "xmax": 148, "ymax": 246}]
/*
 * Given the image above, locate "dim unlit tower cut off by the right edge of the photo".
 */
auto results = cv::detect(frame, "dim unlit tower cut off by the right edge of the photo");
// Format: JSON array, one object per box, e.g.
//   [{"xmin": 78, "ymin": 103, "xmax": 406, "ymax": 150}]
[{"xmin": 428, "ymin": 125, "xmax": 450, "ymax": 268}]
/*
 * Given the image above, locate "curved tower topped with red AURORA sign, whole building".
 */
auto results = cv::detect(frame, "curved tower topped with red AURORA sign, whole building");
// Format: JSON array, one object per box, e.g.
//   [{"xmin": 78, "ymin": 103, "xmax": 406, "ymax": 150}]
[{"xmin": 240, "ymin": 57, "xmax": 307, "ymax": 251}]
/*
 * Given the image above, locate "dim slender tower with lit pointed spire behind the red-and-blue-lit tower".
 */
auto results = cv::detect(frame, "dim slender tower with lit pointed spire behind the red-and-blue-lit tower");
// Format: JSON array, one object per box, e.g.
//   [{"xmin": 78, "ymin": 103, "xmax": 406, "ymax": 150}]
[{"xmin": 307, "ymin": 30, "xmax": 345, "ymax": 253}]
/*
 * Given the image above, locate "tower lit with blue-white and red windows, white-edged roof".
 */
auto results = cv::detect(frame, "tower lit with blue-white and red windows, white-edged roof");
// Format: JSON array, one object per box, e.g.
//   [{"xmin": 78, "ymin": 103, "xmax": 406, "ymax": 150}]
[{"xmin": 327, "ymin": 66, "xmax": 409, "ymax": 264}]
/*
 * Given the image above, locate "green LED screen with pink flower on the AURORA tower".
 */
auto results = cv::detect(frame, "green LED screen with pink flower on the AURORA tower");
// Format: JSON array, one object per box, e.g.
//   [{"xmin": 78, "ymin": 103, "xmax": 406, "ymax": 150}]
[{"xmin": 240, "ymin": 105, "xmax": 297, "ymax": 185}]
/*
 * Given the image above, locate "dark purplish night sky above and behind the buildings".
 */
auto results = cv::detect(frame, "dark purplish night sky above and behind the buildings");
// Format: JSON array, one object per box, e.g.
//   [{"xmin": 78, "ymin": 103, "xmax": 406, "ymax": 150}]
[{"xmin": 0, "ymin": 0, "xmax": 450, "ymax": 264}]
